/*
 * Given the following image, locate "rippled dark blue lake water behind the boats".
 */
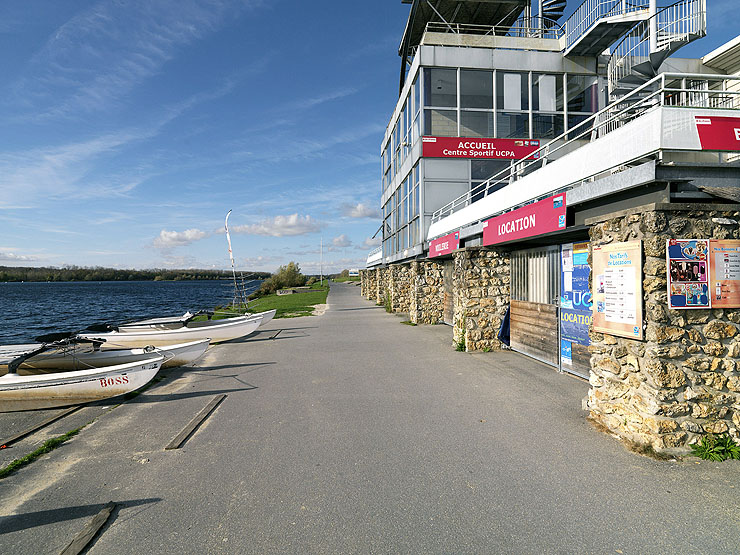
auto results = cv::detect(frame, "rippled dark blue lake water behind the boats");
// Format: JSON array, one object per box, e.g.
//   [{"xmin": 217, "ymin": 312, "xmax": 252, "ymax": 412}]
[{"xmin": 0, "ymin": 280, "xmax": 260, "ymax": 345}]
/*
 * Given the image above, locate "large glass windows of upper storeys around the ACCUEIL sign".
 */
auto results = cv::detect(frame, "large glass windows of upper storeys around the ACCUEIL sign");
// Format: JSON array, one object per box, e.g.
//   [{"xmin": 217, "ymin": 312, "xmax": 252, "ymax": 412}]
[{"xmin": 381, "ymin": 67, "xmax": 598, "ymax": 256}]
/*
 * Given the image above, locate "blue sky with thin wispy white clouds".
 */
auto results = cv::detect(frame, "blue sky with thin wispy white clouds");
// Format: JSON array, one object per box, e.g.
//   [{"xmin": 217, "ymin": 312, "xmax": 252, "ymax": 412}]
[{"xmin": 0, "ymin": 0, "xmax": 737, "ymax": 273}]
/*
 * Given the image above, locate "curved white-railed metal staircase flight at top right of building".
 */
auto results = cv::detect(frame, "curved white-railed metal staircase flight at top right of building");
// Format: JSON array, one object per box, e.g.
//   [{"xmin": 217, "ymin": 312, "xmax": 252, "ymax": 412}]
[{"xmin": 608, "ymin": 0, "xmax": 707, "ymax": 100}]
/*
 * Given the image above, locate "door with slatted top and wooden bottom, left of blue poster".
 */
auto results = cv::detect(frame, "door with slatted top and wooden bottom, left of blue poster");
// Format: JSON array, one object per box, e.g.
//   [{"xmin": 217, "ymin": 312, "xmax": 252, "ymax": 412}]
[{"xmin": 510, "ymin": 246, "xmax": 560, "ymax": 366}]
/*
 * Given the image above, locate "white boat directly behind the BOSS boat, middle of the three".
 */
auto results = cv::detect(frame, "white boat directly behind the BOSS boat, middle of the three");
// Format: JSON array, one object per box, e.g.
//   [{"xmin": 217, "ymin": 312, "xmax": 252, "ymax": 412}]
[{"xmin": 0, "ymin": 339, "xmax": 210, "ymax": 376}]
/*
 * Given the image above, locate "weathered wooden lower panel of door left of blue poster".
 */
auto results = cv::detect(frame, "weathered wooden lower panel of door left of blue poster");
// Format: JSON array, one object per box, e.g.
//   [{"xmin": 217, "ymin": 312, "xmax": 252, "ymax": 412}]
[{"xmin": 510, "ymin": 300, "xmax": 560, "ymax": 366}]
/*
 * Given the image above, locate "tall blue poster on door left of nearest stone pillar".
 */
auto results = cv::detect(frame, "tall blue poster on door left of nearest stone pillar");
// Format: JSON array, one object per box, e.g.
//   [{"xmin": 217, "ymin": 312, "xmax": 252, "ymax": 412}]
[{"xmin": 560, "ymin": 243, "xmax": 592, "ymax": 347}]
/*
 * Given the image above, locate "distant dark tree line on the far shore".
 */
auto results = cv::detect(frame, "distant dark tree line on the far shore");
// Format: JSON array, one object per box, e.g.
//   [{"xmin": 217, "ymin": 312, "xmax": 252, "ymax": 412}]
[{"xmin": 0, "ymin": 266, "xmax": 270, "ymax": 282}]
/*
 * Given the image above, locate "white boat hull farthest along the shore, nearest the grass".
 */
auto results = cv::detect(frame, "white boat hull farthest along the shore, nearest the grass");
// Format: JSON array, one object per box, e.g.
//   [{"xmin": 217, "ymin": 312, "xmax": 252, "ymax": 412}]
[{"xmin": 79, "ymin": 316, "xmax": 262, "ymax": 349}]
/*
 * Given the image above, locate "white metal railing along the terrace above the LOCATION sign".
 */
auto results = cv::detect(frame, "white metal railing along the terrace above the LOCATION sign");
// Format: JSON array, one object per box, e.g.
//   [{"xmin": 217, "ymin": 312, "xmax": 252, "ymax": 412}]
[{"xmin": 432, "ymin": 73, "xmax": 740, "ymax": 223}]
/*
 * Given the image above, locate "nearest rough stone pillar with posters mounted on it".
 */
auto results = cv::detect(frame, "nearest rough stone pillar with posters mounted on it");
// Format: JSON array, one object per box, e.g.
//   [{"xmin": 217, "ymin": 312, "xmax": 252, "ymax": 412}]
[{"xmin": 588, "ymin": 205, "xmax": 740, "ymax": 451}]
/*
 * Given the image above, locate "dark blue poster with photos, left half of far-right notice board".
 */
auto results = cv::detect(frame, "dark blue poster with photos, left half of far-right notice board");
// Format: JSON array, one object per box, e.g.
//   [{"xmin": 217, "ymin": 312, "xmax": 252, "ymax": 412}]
[{"xmin": 666, "ymin": 239, "xmax": 712, "ymax": 308}]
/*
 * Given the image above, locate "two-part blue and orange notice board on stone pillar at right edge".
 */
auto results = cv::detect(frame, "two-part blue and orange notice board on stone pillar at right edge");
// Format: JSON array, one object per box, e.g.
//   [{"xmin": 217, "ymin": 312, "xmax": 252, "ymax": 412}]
[{"xmin": 666, "ymin": 239, "xmax": 740, "ymax": 309}]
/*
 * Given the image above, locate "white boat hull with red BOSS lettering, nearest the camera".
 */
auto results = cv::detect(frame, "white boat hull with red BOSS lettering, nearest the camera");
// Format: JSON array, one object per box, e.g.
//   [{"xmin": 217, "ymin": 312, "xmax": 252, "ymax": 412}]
[{"xmin": 0, "ymin": 355, "xmax": 164, "ymax": 412}]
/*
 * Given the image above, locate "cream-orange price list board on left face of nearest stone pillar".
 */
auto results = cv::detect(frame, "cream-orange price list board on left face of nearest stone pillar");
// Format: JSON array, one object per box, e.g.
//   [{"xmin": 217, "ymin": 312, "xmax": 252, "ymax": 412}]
[{"xmin": 592, "ymin": 241, "xmax": 643, "ymax": 339}]
